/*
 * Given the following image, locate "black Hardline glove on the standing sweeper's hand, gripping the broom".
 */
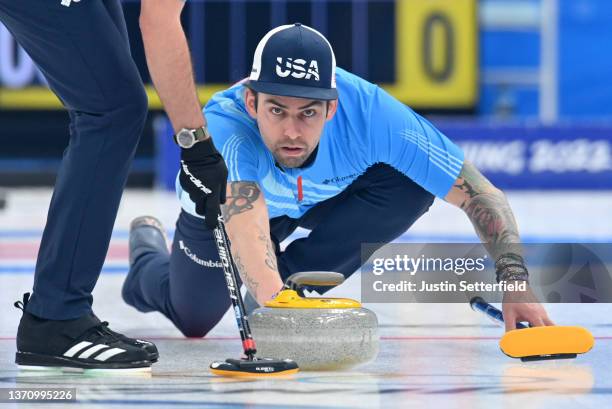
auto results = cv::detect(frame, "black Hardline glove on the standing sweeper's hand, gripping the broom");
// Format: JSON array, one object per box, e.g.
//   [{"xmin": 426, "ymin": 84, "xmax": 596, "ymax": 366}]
[{"xmin": 179, "ymin": 138, "xmax": 227, "ymax": 229}]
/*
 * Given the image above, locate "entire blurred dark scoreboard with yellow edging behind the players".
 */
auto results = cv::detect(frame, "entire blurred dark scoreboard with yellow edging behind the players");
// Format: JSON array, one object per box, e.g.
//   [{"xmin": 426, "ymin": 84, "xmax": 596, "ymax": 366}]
[{"xmin": 0, "ymin": 0, "xmax": 478, "ymax": 110}]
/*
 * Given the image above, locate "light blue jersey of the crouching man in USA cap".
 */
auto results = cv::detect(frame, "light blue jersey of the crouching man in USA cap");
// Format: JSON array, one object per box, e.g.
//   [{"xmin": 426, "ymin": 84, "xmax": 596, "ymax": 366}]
[{"xmin": 176, "ymin": 68, "xmax": 463, "ymax": 218}]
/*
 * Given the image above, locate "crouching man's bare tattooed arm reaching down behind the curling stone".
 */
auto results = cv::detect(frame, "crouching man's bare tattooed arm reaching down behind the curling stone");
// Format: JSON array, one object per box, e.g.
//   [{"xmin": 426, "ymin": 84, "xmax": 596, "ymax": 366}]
[{"xmin": 222, "ymin": 182, "xmax": 283, "ymax": 305}]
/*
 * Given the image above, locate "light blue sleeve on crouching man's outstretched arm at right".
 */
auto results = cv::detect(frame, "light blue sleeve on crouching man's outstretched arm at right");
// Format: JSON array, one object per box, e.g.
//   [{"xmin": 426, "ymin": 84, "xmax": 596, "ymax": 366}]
[{"xmin": 369, "ymin": 88, "xmax": 463, "ymax": 198}]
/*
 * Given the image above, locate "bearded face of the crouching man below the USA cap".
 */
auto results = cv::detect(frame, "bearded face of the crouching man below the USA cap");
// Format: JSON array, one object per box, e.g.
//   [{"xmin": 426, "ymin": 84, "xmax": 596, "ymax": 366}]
[{"xmin": 245, "ymin": 89, "xmax": 338, "ymax": 168}]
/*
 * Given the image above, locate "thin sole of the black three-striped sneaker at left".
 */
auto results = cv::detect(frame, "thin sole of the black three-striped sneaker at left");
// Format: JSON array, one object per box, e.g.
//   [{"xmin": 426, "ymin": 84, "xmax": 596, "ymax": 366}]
[{"xmin": 15, "ymin": 352, "xmax": 151, "ymax": 371}]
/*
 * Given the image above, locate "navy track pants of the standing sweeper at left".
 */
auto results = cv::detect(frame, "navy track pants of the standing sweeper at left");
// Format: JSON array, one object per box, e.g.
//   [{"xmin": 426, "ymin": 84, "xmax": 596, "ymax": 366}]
[{"xmin": 0, "ymin": 0, "xmax": 147, "ymax": 319}]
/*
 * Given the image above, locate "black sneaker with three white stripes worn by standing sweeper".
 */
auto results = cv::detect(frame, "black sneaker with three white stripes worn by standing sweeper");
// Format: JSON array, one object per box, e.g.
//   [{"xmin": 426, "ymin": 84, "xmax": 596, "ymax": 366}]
[{"xmin": 15, "ymin": 293, "xmax": 157, "ymax": 371}]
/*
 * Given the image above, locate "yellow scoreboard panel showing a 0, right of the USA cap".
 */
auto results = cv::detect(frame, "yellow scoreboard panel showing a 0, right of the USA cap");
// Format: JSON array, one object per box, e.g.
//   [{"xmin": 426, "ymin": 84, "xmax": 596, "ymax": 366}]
[{"xmin": 387, "ymin": 0, "xmax": 478, "ymax": 109}]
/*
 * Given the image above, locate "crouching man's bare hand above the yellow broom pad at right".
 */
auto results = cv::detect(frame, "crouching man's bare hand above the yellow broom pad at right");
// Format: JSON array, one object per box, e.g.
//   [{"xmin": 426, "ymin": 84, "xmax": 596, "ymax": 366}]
[{"xmin": 502, "ymin": 286, "xmax": 555, "ymax": 331}]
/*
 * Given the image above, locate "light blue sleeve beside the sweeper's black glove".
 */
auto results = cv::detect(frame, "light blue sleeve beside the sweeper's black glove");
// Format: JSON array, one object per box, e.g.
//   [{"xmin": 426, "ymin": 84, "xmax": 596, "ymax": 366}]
[{"xmin": 206, "ymin": 114, "xmax": 259, "ymax": 182}]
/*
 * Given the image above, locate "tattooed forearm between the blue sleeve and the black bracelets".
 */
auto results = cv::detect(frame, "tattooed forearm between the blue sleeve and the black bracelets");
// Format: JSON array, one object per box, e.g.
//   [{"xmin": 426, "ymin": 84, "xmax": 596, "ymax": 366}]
[{"xmin": 454, "ymin": 162, "xmax": 520, "ymax": 259}]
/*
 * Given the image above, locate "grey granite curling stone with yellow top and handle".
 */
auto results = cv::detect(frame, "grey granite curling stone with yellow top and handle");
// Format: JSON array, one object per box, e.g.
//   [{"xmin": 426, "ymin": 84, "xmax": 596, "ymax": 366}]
[{"xmin": 249, "ymin": 272, "xmax": 379, "ymax": 370}]
